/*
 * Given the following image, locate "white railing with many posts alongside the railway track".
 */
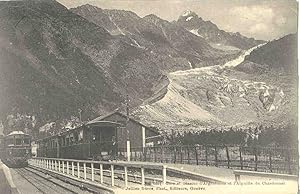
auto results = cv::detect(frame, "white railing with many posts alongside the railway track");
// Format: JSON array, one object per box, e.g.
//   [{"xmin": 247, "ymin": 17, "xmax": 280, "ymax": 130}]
[{"xmin": 29, "ymin": 158, "xmax": 167, "ymax": 187}]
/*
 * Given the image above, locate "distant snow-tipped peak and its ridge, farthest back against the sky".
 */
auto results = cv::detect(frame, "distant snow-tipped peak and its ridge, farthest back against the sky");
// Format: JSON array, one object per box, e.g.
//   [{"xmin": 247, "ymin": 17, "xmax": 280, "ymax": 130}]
[{"xmin": 176, "ymin": 10, "xmax": 264, "ymax": 50}]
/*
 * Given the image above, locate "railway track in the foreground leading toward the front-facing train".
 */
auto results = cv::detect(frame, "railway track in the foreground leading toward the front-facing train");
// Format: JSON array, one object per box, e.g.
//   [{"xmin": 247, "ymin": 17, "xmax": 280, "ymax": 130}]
[{"xmin": 15, "ymin": 167, "xmax": 90, "ymax": 194}]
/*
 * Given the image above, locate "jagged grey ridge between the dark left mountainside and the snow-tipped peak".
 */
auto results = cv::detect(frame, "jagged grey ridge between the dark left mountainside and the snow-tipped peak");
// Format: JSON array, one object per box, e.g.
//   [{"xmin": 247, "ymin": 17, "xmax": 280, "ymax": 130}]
[{"xmin": 71, "ymin": 5, "xmax": 237, "ymax": 70}]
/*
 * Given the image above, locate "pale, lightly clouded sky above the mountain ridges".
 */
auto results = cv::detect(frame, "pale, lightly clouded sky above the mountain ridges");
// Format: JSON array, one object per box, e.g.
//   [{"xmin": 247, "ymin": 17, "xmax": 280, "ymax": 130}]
[{"xmin": 57, "ymin": 0, "xmax": 298, "ymax": 40}]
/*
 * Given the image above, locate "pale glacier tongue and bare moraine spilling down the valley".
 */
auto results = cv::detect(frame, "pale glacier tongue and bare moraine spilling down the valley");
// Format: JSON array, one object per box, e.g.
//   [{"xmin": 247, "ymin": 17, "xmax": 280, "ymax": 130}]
[{"xmin": 134, "ymin": 39, "xmax": 297, "ymax": 131}]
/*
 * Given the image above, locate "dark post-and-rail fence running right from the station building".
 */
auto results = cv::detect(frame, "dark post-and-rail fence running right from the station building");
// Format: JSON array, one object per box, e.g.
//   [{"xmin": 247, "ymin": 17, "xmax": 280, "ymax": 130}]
[{"xmin": 123, "ymin": 145, "xmax": 298, "ymax": 174}]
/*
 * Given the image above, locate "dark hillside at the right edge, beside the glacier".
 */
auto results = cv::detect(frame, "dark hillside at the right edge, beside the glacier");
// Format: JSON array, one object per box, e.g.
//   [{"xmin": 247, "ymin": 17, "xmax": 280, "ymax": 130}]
[{"xmin": 235, "ymin": 34, "xmax": 298, "ymax": 125}]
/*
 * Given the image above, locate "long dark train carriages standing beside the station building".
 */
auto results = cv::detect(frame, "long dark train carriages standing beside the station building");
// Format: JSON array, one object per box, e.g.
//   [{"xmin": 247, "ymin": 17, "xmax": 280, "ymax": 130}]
[{"xmin": 36, "ymin": 121, "xmax": 126, "ymax": 160}]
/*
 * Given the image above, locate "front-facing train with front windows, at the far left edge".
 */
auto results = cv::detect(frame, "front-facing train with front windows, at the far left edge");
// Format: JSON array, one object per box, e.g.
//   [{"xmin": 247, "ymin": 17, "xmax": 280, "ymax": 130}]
[{"xmin": 1, "ymin": 131, "xmax": 32, "ymax": 167}]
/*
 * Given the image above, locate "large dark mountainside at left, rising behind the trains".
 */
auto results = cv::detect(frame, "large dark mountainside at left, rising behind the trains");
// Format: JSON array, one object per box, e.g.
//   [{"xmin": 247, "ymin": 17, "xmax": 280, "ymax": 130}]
[{"xmin": 0, "ymin": 1, "xmax": 164, "ymax": 130}]
